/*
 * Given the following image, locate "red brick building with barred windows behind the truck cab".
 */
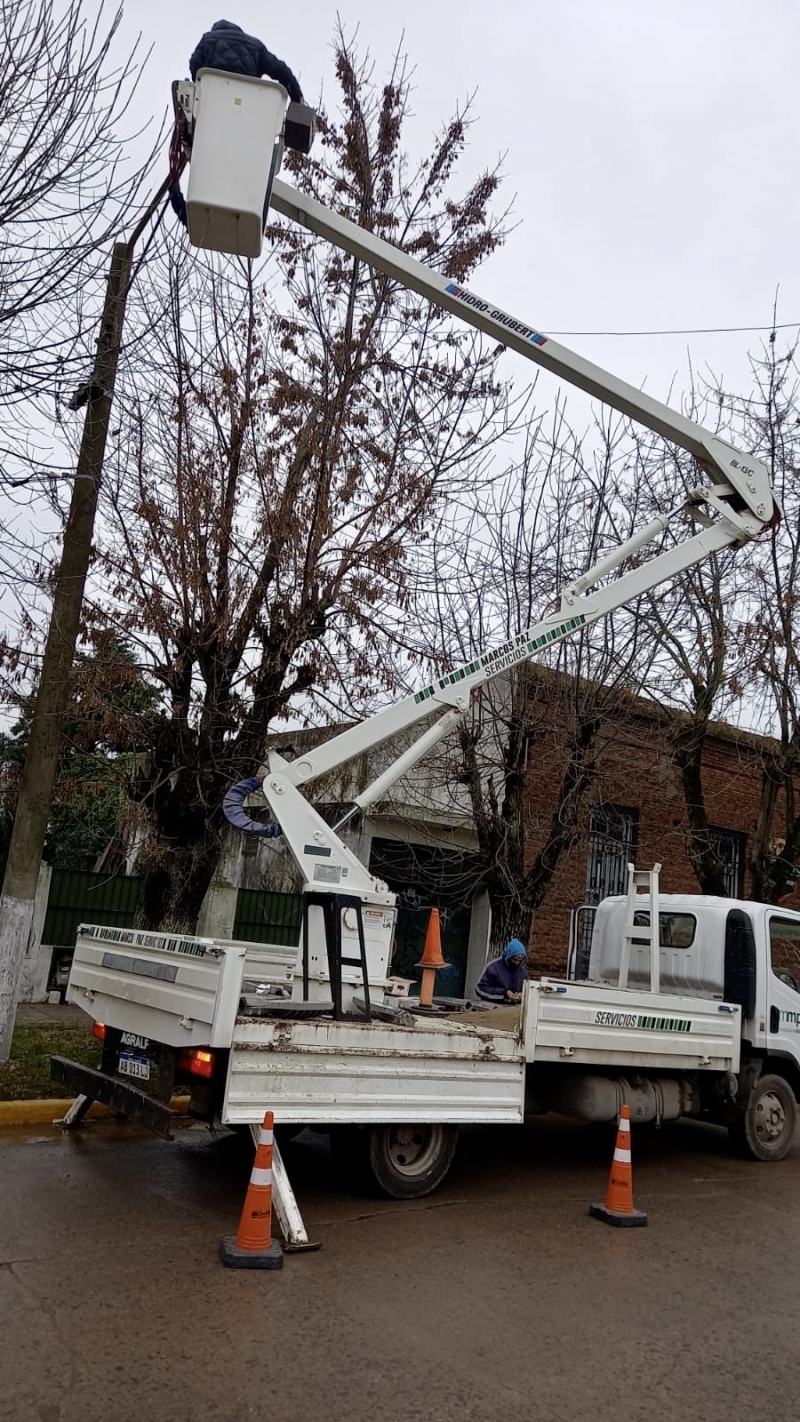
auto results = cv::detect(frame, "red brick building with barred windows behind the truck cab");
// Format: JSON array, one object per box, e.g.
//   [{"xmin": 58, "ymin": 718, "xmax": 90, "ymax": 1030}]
[{"xmin": 526, "ymin": 675, "xmax": 800, "ymax": 974}]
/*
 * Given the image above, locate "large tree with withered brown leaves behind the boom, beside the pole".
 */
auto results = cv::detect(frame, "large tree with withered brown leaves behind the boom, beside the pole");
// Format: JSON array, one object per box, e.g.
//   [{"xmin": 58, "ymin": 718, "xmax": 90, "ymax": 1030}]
[{"xmin": 88, "ymin": 34, "xmax": 520, "ymax": 927}]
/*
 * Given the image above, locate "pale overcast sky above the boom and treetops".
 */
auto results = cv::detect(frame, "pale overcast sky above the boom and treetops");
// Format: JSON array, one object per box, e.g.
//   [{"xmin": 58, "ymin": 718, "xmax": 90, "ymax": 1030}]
[{"xmin": 117, "ymin": 0, "xmax": 800, "ymax": 412}]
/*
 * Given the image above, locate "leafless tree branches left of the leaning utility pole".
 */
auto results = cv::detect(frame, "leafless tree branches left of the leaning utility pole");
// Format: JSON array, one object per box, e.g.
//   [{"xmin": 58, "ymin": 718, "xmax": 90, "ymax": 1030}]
[{"xmin": 0, "ymin": 0, "xmax": 153, "ymax": 711}]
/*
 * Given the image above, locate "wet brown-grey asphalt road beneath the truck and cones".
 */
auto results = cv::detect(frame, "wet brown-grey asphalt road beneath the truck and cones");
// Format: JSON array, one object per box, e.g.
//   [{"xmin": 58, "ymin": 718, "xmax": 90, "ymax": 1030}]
[{"xmin": 0, "ymin": 1118, "xmax": 800, "ymax": 1422}]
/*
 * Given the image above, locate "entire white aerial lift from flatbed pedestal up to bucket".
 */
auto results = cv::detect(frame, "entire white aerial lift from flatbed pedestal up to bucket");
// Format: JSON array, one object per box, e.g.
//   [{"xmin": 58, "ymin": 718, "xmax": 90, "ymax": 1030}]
[{"xmin": 180, "ymin": 71, "xmax": 777, "ymax": 1015}]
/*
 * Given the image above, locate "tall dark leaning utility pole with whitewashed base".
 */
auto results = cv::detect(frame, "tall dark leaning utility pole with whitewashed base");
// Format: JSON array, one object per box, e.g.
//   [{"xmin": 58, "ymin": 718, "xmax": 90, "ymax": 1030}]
[{"xmin": 0, "ymin": 182, "xmax": 174, "ymax": 1062}]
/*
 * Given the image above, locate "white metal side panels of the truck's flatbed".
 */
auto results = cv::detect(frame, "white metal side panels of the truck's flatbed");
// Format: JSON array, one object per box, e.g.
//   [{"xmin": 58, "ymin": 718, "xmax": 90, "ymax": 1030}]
[{"xmin": 68, "ymin": 926, "xmax": 740, "ymax": 1126}]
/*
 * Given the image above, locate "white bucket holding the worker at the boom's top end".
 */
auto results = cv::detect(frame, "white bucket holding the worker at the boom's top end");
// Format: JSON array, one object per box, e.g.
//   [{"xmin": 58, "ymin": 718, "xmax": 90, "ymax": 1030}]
[{"xmin": 186, "ymin": 70, "xmax": 288, "ymax": 257}]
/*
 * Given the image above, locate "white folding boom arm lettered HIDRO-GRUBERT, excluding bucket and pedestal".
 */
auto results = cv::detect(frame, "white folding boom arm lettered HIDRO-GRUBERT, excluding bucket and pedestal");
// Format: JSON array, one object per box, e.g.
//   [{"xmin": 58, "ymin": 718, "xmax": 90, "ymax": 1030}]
[{"xmin": 251, "ymin": 179, "xmax": 774, "ymax": 893}]
